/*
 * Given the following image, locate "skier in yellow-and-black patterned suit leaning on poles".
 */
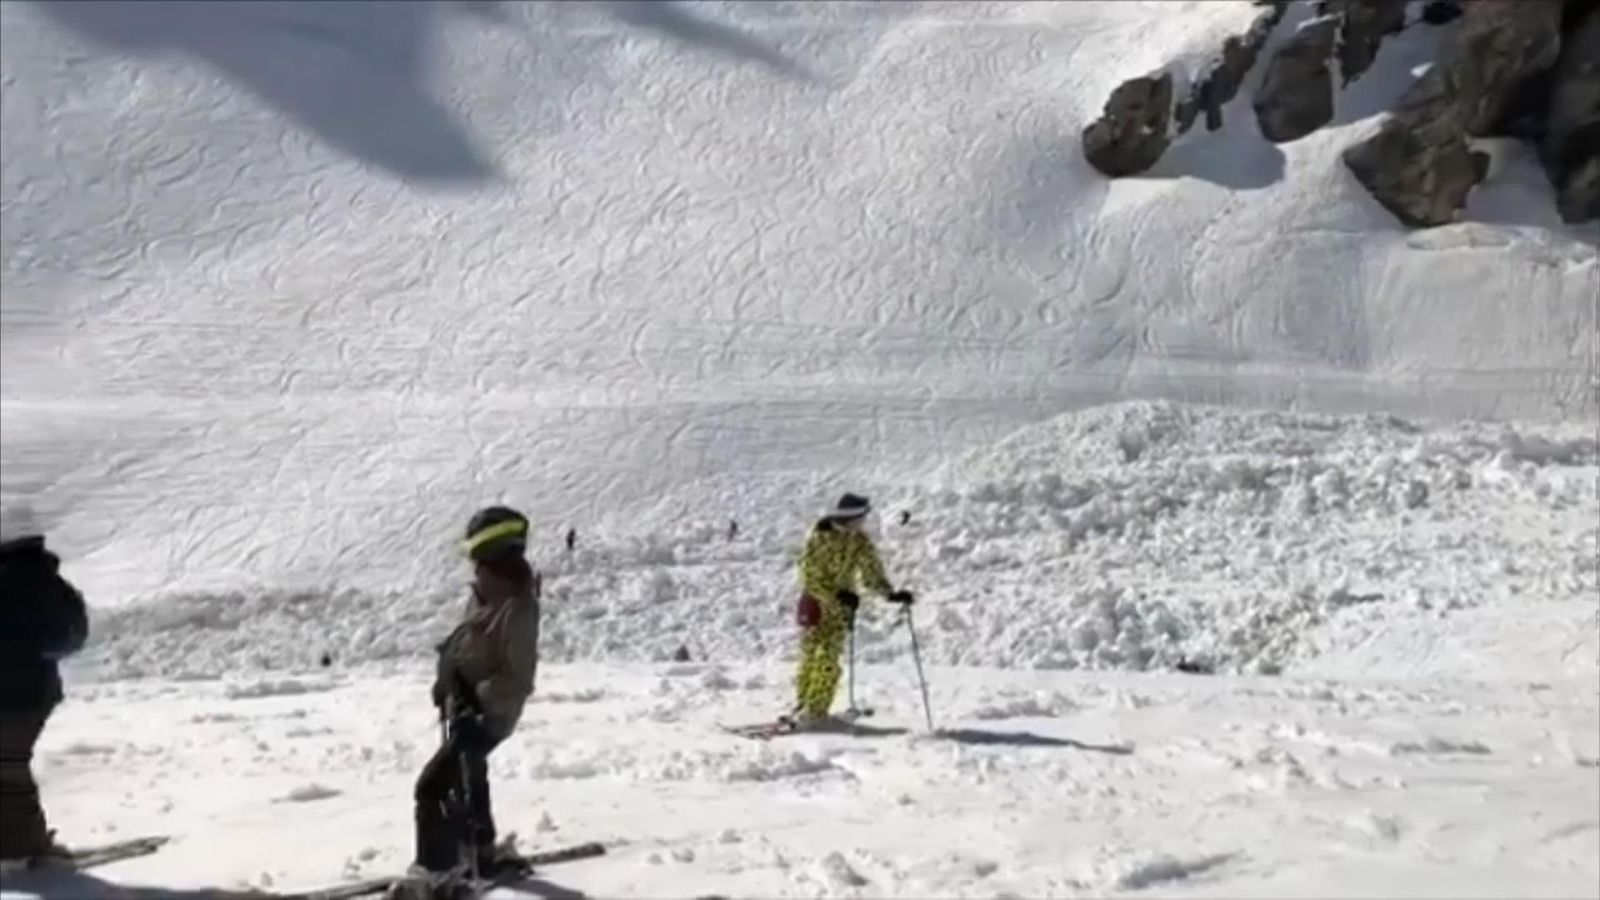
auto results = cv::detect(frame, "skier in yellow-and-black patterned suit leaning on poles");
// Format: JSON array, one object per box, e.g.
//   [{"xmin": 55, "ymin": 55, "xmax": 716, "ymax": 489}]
[{"xmin": 786, "ymin": 493, "xmax": 914, "ymax": 727}]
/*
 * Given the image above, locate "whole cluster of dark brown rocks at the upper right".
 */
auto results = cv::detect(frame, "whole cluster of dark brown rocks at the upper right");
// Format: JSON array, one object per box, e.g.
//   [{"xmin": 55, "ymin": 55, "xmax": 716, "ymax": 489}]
[{"xmin": 1083, "ymin": 0, "xmax": 1600, "ymax": 227}]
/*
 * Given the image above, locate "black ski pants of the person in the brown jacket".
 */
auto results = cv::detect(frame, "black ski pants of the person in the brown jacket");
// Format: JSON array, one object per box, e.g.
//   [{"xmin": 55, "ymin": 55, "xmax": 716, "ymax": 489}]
[{"xmin": 416, "ymin": 722, "xmax": 501, "ymax": 871}]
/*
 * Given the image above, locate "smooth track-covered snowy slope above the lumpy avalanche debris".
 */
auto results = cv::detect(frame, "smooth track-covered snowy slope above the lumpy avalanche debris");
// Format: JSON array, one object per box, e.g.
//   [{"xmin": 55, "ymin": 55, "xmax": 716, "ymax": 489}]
[{"xmin": 0, "ymin": 2, "xmax": 1600, "ymax": 602}]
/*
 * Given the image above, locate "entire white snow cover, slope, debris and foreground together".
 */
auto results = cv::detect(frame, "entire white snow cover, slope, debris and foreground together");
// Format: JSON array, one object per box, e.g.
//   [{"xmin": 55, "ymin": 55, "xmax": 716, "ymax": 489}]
[{"xmin": 0, "ymin": 0, "xmax": 1600, "ymax": 897}]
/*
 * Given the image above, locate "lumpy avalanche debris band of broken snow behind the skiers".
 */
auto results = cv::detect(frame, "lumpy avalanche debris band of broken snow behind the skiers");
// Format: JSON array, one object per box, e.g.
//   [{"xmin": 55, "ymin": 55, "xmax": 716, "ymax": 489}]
[{"xmin": 68, "ymin": 402, "xmax": 1600, "ymax": 679}]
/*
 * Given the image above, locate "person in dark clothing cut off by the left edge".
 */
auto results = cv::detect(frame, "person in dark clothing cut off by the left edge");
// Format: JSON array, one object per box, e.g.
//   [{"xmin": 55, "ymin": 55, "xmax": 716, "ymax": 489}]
[{"xmin": 0, "ymin": 535, "xmax": 90, "ymax": 865}]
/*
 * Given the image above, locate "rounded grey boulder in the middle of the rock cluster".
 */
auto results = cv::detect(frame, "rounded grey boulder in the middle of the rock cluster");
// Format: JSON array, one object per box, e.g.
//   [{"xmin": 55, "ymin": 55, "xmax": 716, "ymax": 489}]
[{"xmin": 1251, "ymin": 16, "xmax": 1339, "ymax": 144}]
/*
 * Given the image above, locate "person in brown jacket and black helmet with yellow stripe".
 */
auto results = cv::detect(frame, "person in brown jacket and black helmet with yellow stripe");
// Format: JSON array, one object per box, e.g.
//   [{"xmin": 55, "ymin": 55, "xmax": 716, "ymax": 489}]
[{"xmin": 411, "ymin": 506, "xmax": 541, "ymax": 887}]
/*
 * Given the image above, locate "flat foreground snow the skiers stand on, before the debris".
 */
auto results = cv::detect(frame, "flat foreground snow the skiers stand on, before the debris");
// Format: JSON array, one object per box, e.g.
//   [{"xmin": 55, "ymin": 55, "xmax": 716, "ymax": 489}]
[{"xmin": 6, "ymin": 663, "xmax": 1600, "ymax": 900}]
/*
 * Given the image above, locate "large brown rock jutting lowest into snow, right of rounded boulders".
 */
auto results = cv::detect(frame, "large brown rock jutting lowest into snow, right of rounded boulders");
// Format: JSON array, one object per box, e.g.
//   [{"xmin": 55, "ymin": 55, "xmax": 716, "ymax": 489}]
[{"xmin": 1344, "ymin": 0, "xmax": 1562, "ymax": 226}]
